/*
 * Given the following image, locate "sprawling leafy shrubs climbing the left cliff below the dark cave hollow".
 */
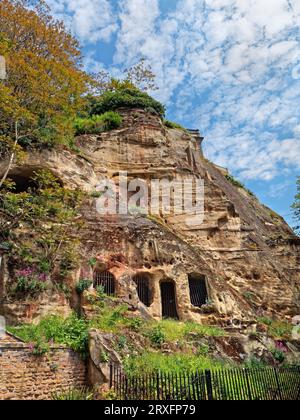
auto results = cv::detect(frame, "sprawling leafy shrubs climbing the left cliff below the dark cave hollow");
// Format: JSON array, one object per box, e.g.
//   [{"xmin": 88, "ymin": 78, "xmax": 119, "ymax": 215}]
[{"xmin": 0, "ymin": 171, "xmax": 83, "ymax": 295}]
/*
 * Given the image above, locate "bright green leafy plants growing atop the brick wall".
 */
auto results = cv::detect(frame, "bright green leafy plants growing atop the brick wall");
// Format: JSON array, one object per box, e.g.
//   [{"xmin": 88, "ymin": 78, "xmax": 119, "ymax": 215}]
[{"xmin": 9, "ymin": 314, "xmax": 89, "ymax": 355}]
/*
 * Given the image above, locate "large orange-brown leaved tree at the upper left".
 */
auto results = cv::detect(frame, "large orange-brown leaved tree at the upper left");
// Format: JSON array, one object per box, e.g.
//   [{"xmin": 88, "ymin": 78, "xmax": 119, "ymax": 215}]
[{"xmin": 0, "ymin": 0, "xmax": 89, "ymax": 182}]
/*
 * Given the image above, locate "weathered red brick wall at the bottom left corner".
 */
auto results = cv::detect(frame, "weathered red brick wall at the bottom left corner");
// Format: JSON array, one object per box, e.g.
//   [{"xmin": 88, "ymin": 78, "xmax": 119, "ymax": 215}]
[{"xmin": 0, "ymin": 340, "xmax": 86, "ymax": 400}]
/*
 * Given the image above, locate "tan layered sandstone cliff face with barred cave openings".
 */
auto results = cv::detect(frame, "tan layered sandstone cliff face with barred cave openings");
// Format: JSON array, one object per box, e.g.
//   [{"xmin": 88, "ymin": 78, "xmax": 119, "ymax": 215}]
[{"xmin": 0, "ymin": 110, "xmax": 300, "ymax": 324}]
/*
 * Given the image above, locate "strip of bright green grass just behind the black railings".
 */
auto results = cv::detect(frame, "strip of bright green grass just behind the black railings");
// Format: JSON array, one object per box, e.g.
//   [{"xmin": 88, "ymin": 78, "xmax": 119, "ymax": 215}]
[{"xmin": 125, "ymin": 351, "xmax": 225, "ymax": 375}]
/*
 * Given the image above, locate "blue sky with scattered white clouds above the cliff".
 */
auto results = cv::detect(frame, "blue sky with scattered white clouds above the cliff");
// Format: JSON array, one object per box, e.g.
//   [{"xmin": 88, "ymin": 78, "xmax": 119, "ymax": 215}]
[{"xmin": 47, "ymin": 0, "xmax": 300, "ymax": 228}]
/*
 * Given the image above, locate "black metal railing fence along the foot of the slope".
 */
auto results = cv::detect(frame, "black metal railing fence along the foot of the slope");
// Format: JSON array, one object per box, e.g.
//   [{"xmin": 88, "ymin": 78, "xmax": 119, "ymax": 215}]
[{"xmin": 110, "ymin": 365, "xmax": 300, "ymax": 401}]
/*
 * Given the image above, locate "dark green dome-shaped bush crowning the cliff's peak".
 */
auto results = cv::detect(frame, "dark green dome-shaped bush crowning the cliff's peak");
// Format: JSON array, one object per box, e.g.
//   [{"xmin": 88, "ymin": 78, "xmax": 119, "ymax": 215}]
[{"xmin": 91, "ymin": 87, "xmax": 165, "ymax": 117}]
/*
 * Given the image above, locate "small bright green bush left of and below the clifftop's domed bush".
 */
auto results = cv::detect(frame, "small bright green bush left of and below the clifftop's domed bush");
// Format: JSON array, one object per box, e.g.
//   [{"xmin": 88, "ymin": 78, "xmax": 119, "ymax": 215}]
[{"xmin": 74, "ymin": 111, "xmax": 122, "ymax": 135}]
